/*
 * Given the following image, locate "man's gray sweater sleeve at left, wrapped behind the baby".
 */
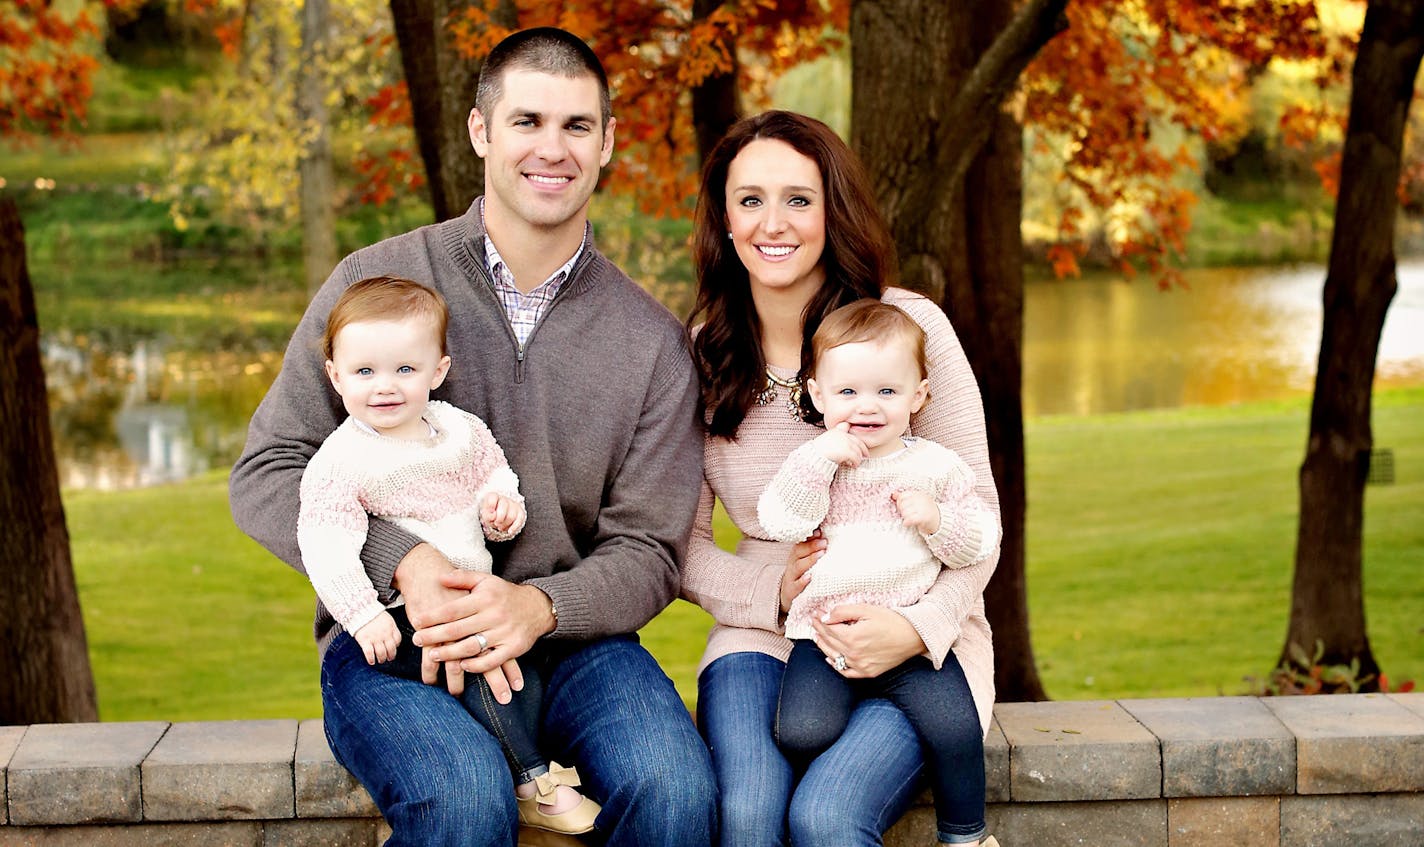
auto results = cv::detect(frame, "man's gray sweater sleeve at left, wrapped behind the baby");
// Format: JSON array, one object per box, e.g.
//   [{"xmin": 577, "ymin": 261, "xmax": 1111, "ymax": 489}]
[{"xmin": 228, "ymin": 256, "xmax": 420, "ymax": 602}]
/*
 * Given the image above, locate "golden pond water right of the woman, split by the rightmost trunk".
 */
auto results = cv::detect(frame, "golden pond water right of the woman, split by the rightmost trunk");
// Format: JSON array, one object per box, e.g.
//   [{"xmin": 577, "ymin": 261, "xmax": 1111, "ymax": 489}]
[{"xmin": 1024, "ymin": 262, "xmax": 1424, "ymax": 416}]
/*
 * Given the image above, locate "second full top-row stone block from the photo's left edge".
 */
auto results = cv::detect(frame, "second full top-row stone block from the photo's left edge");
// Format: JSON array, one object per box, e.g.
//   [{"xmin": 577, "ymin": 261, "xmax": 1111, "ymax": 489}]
[{"xmin": 141, "ymin": 720, "xmax": 298, "ymax": 820}]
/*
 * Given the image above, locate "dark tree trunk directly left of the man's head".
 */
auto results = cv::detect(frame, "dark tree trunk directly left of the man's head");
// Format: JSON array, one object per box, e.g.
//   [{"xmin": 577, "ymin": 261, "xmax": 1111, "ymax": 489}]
[{"xmin": 390, "ymin": 0, "xmax": 518, "ymax": 221}]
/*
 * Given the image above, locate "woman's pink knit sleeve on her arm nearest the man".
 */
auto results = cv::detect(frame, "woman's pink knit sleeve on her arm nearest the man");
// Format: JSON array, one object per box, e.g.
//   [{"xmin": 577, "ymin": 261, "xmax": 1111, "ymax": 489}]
[{"xmin": 682, "ymin": 472, "xmax": 785, "ymax": 633}]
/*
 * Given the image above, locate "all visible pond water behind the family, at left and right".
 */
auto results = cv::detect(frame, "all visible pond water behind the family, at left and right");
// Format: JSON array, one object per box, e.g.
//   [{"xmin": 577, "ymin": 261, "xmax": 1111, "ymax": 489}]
[{"xmin": 31, "ymin": 256, "xmax": 1424, "ymax": 490}]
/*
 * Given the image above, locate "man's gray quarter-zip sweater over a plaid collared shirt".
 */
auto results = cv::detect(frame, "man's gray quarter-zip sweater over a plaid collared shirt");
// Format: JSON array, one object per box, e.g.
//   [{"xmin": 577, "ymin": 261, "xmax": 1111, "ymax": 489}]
[{"xmin": 229, "ymin": 201, "xmax": 702, "ymax": 652}]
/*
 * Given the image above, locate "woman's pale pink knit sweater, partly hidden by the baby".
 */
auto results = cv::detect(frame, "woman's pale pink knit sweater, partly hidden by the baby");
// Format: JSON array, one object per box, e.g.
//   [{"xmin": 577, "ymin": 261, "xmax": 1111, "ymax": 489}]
[{"xmin": 682, "ymin": 289, "xmax": 998, "ymax": 732}]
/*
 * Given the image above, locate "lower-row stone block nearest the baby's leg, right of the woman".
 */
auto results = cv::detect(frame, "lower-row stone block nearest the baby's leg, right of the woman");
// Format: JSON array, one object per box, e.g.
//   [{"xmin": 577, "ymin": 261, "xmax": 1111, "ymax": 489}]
[{"xmin": 987, "ymin": 800, "xmax": 1168, "ymax": 847}]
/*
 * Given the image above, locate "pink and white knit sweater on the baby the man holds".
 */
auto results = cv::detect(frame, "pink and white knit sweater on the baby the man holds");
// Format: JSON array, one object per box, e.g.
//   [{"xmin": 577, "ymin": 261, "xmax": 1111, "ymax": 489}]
[{"xmin": 296, "ymin": 400, "xmax": 524, "ymax": 632}]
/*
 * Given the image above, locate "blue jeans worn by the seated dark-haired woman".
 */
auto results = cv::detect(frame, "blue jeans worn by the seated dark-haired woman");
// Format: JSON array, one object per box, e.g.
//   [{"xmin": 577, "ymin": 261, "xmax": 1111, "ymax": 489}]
[{"xmin": 698, "ymin": 652, "xmax": 923, "ymax": 847}]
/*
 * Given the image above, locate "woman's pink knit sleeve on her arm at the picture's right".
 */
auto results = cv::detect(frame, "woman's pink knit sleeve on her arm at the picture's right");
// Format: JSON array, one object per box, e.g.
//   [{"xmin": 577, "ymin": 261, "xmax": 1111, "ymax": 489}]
[{"xmin": 886, "ymin": 289, "xmax": 998, "ymax": 668}]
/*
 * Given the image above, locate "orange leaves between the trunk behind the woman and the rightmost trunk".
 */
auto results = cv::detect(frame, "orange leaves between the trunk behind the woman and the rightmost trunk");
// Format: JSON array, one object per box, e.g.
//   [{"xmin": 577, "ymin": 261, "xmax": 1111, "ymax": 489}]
[{"xmin": 1021, "ymin": 0, "xmax": 1339, "ymax": 279}]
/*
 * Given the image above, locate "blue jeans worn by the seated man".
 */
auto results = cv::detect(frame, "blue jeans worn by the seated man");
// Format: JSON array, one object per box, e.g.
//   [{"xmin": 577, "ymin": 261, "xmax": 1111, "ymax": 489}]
[{"xmin": 322, "ymin": 632, "xmax": 716, "ymax": 847}]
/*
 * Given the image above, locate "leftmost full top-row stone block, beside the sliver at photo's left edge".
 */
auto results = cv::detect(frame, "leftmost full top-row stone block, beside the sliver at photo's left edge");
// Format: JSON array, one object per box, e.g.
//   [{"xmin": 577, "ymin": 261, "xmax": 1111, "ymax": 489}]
[{"xmin": 6, "ymin": 720, "xmax": 168, "ymax": 826}]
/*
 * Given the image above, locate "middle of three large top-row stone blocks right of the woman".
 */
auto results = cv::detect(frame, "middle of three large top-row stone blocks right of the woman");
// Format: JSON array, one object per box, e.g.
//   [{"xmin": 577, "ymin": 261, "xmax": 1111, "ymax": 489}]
[{"xmin": 1119, "ymin": 698, "xmax": 1296, "ymax": 797}]
